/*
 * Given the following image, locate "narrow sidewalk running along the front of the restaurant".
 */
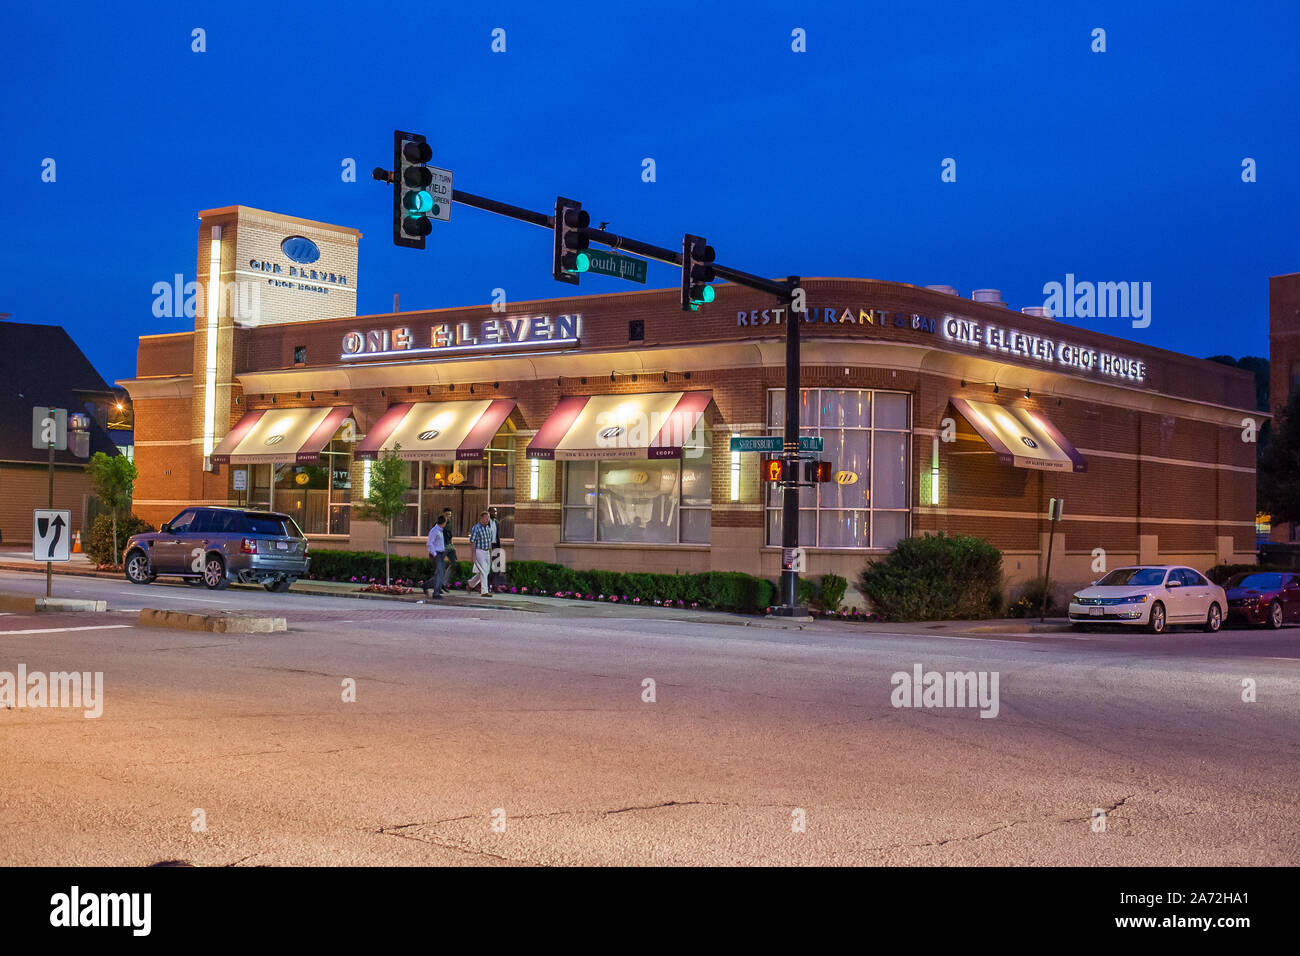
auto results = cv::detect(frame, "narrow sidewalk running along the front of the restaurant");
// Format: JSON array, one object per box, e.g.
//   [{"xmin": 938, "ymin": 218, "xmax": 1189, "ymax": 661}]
[{"xmin": 0, "ymin": 550, "xmax": 1070, "ymax": 636}]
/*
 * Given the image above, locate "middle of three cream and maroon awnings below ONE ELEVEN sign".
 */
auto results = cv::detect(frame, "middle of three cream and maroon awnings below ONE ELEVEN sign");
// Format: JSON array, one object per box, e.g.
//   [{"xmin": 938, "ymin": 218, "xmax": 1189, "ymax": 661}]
[{"xmin": 355, "ymin": 398, "xmax": 515, "ymax": 462}]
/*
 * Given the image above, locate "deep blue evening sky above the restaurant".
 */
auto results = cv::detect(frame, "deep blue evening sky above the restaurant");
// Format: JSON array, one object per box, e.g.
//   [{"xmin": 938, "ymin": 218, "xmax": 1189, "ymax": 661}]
[{"xmin": 0, "ymin": 0, "xmax": 1300, "ymax": 380}]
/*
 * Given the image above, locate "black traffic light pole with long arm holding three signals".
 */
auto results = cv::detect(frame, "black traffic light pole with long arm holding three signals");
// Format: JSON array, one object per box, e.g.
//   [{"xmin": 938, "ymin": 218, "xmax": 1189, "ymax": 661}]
[{"xmin": 373, "ymin": 169, "xmax": 806, "ymax": 617}]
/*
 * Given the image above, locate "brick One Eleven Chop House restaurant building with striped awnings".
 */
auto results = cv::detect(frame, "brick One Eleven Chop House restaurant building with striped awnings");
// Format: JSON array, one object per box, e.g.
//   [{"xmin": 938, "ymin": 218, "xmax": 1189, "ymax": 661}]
[{"xmin": 121, "ymin": 207, "xmax": 1255, "ymax": 598}]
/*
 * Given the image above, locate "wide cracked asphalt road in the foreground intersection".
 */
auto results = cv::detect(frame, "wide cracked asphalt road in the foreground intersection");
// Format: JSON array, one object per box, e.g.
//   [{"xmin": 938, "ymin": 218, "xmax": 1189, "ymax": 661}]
[{"xmin": 0, "ymin": 572, "xmax": 1300, "ymax": 865}]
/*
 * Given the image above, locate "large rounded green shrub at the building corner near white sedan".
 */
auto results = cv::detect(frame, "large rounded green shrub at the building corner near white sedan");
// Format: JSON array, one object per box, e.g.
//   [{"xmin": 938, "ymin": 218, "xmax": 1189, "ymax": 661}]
[{"xmin": 862, "ymin": 532, "xmax": 1002, "ymax": 620}]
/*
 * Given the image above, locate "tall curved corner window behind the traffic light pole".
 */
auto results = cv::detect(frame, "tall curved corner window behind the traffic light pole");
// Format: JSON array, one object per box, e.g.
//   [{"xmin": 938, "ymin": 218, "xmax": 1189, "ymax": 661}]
[{"xmin": 767, "ymin": 389, "xmax": 911, "ymax": 548}]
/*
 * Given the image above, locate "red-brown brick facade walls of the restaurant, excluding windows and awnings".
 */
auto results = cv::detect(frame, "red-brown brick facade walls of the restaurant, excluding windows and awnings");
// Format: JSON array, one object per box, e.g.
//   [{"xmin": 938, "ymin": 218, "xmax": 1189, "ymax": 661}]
[{"xmin": 124, "ymin": 273, "xmax": 1255, "ymax": 595}]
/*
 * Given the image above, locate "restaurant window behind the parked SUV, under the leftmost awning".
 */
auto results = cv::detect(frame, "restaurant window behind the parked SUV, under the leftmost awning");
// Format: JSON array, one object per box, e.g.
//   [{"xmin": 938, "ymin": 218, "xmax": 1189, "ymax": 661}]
[{"xmin": 239, "ymin": 429, "xmax": 352, "ymax": 535}]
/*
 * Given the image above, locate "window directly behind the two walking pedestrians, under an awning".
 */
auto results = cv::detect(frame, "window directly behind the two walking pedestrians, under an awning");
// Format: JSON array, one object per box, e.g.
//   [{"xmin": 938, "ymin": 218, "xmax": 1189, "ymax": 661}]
[{"xmin": 393, "ymin": 432, "xmax": 515, "ymax": 540}]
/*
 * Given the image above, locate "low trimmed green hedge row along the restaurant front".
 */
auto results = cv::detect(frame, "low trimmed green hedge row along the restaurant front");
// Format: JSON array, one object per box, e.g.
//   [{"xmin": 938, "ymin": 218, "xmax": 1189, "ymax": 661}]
[{"xmin": 311, "ymin": 550, "xmax": 776, "ymax": 614}]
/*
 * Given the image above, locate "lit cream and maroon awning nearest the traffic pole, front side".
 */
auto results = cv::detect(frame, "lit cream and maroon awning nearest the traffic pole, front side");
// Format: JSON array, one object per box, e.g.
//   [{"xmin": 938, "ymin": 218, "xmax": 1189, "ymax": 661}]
[{"xmin": 527, "ymin": 390, "xmax": 714, "ymax": 460}]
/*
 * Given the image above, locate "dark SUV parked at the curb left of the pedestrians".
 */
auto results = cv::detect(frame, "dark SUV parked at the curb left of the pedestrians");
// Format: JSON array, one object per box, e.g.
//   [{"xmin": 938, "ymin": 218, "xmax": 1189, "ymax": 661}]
[{"xmin": 122, "ymin": 507, "xmax": 311, "ymax": 592}]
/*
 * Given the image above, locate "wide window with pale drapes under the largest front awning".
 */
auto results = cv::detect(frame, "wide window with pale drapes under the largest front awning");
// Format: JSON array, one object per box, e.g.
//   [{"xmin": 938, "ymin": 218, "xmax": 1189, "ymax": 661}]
[{"xmin": 563, "ymin": 433, "xmax": 714, "ymax": 544}]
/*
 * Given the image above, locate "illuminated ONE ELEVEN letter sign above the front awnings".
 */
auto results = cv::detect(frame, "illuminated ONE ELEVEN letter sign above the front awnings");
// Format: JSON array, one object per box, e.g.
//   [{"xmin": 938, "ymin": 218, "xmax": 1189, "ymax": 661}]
[{"xmin": 341, "ymin": 313, "xmax": 582, "ymax": 360}]
